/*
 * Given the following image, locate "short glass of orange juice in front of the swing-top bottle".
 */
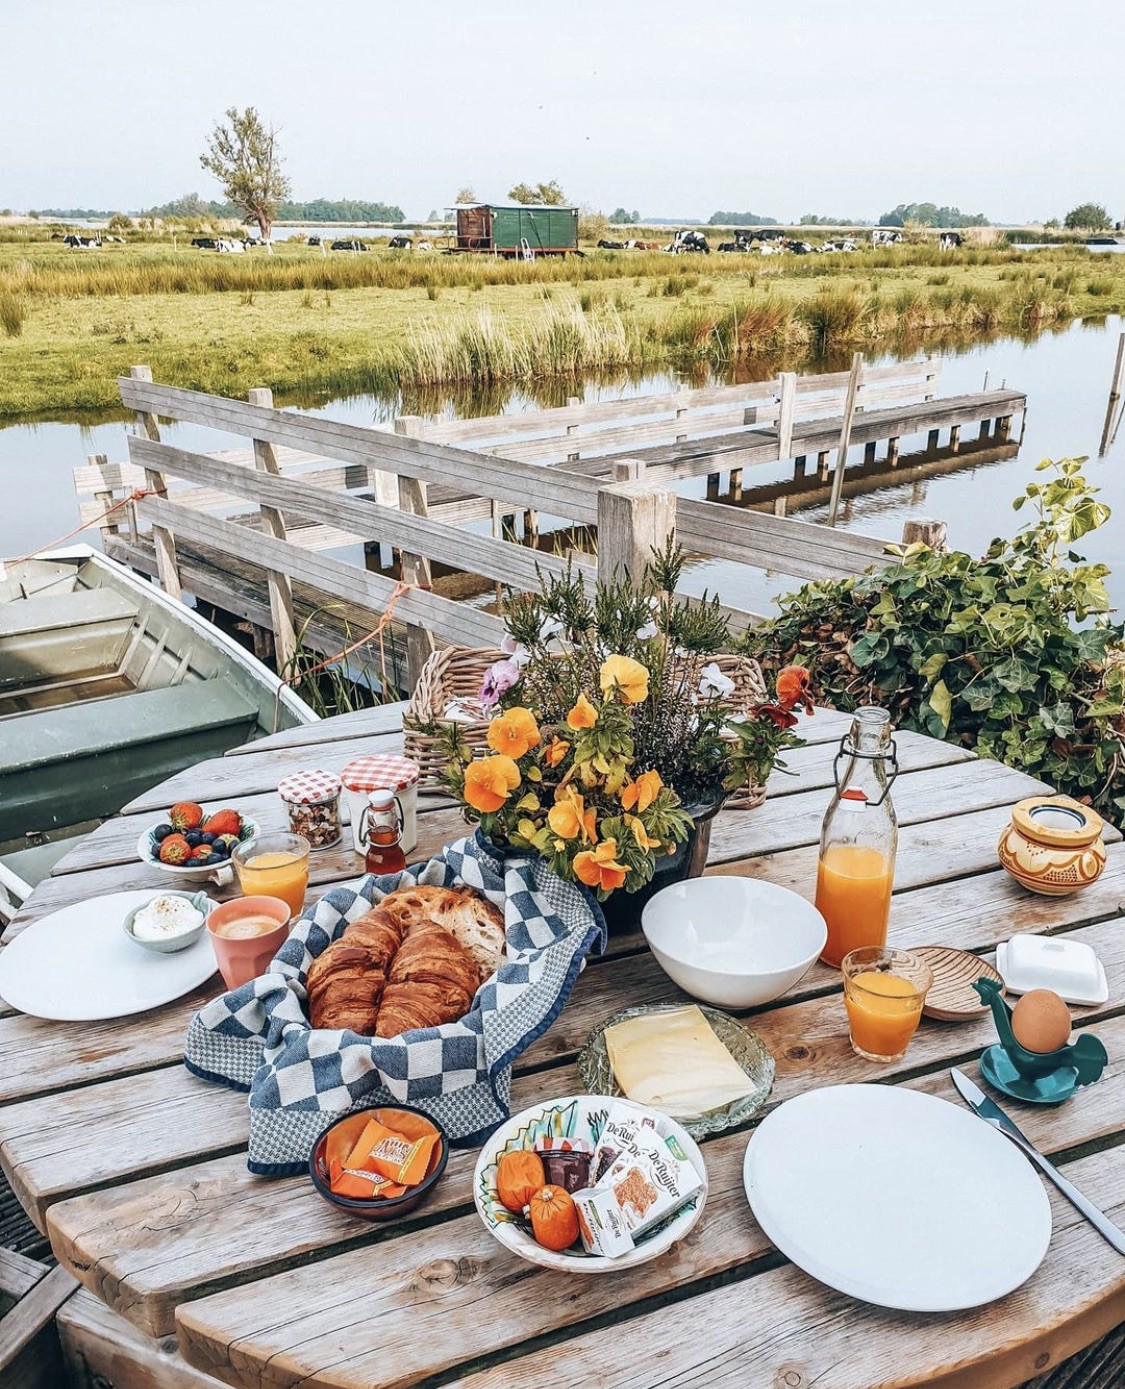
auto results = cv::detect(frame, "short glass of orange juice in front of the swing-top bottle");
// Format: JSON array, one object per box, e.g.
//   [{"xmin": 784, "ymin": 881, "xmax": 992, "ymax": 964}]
[{"xmin": 840, "ymin": 946, "xmax": 933, "ymax": 1061}]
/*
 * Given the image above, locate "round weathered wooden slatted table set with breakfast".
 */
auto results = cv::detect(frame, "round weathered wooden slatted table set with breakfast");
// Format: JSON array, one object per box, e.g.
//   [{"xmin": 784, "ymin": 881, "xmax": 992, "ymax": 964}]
[{"xmin": 0, "ymin": 706, "xmax": 1125, "ymax": 1389}]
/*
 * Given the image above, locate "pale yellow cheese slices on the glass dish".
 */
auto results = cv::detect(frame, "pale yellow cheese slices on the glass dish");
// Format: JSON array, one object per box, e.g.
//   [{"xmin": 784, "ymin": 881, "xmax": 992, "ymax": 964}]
[{"xmin": 604, "ymin": 1004, "xmax": 754, "ymax": 1118}]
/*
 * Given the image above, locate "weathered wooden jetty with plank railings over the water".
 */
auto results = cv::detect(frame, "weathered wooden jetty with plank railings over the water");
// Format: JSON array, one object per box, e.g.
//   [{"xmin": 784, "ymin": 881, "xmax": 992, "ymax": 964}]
[{"xmin": 75, "ymin": 354, "xmax": 1026, "ymax": 694}]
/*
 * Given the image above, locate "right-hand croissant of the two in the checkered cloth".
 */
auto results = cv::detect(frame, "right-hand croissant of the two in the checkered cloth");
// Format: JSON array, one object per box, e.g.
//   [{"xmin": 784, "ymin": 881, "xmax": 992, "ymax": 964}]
[{"xmin": 375, "ymin": 921, "xmax": 479, "ymax": 1038}]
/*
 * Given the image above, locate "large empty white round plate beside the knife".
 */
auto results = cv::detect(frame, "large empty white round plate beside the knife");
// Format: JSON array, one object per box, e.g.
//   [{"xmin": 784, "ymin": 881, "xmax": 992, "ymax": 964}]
[{"xmin": 743, "ymin": 1085, "xmax": 1051, "ymax": 1311}]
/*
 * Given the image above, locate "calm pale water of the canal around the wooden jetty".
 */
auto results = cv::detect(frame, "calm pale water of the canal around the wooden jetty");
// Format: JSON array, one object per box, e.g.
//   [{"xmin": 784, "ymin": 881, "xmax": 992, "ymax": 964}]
[{"xmin": 0, "ymin": 318, "xmax": 1125, "ymax": 611}]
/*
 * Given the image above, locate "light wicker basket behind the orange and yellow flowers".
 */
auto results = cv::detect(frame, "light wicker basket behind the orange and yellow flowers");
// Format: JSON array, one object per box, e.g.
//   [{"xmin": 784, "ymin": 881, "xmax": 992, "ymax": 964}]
[{"xmin": 403, "ymin": 646, "xmax": 767, "ymax": 810}]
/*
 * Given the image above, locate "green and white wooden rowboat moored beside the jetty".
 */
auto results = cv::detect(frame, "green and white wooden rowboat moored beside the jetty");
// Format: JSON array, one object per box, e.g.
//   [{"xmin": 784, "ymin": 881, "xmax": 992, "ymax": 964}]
[{"xmin": 0, "ymin": 546, "xmax": 317, "ymax": 917}]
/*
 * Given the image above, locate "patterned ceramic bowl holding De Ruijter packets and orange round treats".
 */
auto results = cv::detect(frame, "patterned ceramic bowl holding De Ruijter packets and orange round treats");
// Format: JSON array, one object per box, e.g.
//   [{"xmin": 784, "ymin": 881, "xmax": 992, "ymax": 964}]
[{"xmin": 472, "ymin": 1095, "xmax": 707, "ymax": 1274}]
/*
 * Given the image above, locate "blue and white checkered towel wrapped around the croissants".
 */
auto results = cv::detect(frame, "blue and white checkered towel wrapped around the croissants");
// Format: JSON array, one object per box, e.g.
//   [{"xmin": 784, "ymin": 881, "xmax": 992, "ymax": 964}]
[{"xmin": 183, "ymin": 832, "xmax": 606, "ymax": 1176}]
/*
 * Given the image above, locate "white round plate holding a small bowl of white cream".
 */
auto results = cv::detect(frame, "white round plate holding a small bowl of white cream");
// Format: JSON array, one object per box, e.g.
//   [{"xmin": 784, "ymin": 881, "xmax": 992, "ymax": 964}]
[{"xmin": 0, "ymin": 888, "xmax": 218, "ymax": 1022}]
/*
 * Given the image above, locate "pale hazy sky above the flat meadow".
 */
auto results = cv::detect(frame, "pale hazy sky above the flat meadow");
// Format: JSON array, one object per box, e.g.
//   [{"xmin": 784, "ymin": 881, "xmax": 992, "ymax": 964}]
[{"xmin": 0, "ymin": 0, "xmax": 1125, "ymax": 222}]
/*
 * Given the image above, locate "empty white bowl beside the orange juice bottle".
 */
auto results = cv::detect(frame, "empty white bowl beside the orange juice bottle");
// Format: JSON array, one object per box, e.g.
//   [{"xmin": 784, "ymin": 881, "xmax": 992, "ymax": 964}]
[{"xmin": 640, "ymin": 874, "xmax": 828, "ymax": 1008}]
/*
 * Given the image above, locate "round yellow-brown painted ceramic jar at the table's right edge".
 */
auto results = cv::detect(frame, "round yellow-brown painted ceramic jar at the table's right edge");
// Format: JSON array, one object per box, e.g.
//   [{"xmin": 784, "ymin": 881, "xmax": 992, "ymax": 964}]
[{"xmin": 997, "ymin": 796, "xmax": 1106, "ymax": 897}]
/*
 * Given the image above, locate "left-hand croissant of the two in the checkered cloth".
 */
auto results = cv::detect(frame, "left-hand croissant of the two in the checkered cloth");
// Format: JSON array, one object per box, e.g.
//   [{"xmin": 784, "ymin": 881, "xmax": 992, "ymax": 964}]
[{"xmin": 306, "ymin": 907, "xmax": 403, "ymax": 1036}]
